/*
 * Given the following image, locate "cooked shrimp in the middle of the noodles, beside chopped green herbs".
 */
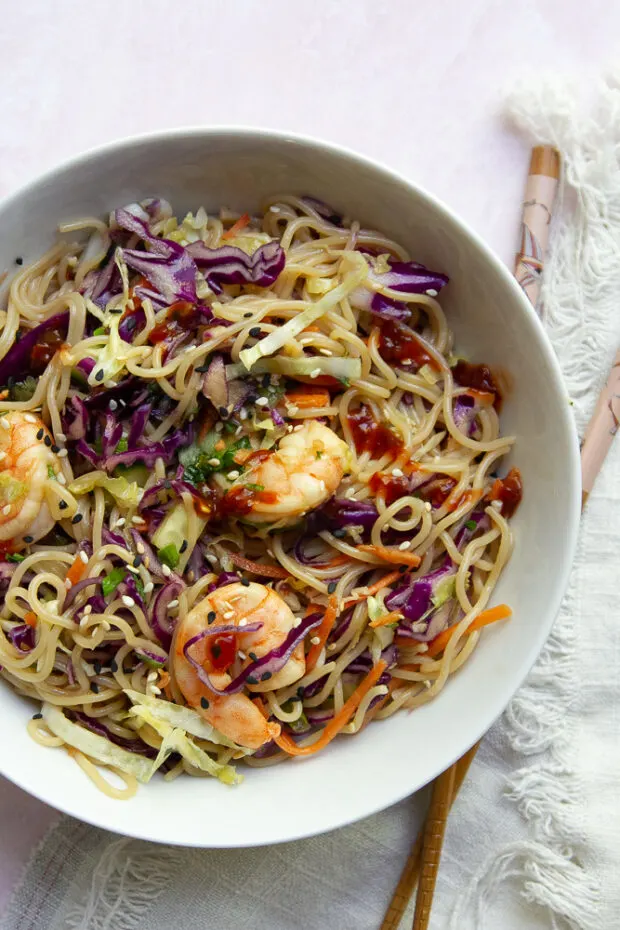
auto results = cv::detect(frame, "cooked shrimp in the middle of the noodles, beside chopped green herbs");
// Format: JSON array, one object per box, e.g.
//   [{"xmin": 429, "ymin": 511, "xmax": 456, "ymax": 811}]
[{"xmin": 235, "ymin": 420, "xmax": 351, "ymax": 526}]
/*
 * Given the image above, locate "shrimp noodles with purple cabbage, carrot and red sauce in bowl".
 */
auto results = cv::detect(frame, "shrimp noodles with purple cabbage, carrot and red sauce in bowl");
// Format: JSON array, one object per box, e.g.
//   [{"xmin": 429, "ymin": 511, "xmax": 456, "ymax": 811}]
[{"xmin": 0, "ymin": 196, "xmax": 521, "ymax": 797}]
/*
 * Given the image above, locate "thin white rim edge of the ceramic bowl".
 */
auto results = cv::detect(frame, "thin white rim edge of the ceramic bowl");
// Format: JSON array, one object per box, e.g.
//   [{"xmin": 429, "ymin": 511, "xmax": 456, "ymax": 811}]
[{"xmin": 0, "ymin": 124, "xmax": 581, "ymax": 848}]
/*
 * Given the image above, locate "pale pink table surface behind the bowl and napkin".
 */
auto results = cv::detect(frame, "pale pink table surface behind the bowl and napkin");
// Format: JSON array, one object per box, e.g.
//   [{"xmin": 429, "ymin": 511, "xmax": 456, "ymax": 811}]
[{"xmin": 0, "ymin": 0, "xmax": 620, "ymax": 910}]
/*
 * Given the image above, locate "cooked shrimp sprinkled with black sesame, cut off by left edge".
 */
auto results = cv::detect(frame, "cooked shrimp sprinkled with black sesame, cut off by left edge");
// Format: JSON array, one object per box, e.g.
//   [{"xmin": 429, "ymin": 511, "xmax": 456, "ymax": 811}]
[{"xmin": 0, "ymin": 411, "xmax": 60, "ymax": 547}]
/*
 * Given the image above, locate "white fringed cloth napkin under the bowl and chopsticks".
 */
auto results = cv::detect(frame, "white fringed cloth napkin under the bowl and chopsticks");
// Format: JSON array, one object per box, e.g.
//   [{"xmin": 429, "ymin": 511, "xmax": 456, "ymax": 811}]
[{"xmin": 0, "ymin": 81, "xmax": 620, "ymax": 930}]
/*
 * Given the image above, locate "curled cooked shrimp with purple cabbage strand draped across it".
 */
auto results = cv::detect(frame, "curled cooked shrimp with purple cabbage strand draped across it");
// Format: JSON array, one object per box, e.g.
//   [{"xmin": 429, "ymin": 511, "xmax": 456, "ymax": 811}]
[{"xmin": 172, "ymin": 582, "xmax": 306, "ymax": 749}]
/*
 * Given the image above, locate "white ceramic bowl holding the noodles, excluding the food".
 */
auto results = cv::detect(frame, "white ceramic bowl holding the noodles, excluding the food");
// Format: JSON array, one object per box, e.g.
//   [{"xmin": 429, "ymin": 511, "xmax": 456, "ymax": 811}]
[{"xmin": 0, "ymin": 129, "xmax": 580, "ymax": 847}]
